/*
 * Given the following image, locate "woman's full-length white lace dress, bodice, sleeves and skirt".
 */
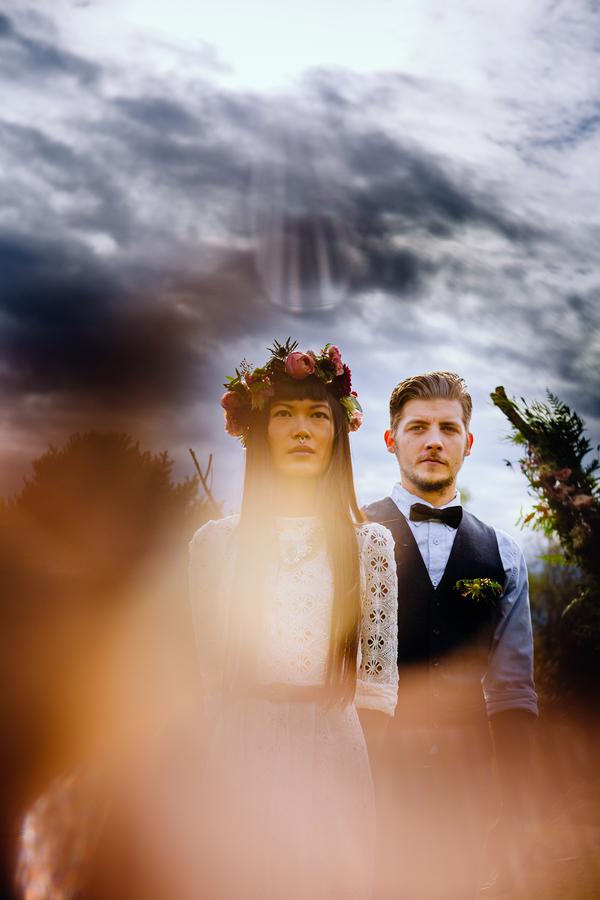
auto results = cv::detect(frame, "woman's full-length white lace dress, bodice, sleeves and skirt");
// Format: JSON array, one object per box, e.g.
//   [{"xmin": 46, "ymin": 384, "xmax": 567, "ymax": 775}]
[{"xmin": 190, "ymin": 517, "xmax": 397, "ymax": 900}]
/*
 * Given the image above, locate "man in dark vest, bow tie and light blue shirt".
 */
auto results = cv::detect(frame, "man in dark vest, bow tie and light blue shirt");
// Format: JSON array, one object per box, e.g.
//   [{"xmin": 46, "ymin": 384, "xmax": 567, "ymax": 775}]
[{"xmin": 364, "ymin": 372, "xmax": 537, "ymax": 900}]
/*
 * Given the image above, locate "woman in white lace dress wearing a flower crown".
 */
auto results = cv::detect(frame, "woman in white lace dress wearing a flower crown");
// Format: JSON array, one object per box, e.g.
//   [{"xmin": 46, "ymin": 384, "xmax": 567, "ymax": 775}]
[{"xmin": 190, "ymin": 340, "xmax": 397, "ymax": 900}]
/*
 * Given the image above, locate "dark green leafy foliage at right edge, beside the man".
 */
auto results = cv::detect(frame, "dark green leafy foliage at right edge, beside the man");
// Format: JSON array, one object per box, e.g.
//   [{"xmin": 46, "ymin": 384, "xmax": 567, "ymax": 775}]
[{"xmin": 491, "ymin": 387, "xmax": 600, "ymax": 700}]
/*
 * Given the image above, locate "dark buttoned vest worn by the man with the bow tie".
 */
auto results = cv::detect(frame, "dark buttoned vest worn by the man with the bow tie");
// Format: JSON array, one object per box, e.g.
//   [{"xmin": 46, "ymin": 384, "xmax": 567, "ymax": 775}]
[{"xmin": 364, "ymin": 497, "xmax": 505, "ymax": 725}]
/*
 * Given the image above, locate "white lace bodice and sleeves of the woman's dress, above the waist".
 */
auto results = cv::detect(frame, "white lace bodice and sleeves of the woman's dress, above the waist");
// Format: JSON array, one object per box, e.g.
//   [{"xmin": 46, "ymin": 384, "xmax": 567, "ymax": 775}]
[{"xmin": 190, "ymin": 517, "xmax": 397, "ymax": 715}]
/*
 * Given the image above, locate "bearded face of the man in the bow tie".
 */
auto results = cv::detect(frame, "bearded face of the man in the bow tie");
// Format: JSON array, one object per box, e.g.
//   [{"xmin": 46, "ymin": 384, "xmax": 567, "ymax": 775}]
[{"xmin": 385, "ymin": 399, "xmax": 473, "ymax": 494}]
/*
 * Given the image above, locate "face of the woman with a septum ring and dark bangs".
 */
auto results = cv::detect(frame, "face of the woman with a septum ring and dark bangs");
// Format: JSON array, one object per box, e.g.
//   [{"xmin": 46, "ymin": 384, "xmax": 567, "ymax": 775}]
[{"xmin": 267, "ymin": 400, "xmax": 334, "ymax": 478}]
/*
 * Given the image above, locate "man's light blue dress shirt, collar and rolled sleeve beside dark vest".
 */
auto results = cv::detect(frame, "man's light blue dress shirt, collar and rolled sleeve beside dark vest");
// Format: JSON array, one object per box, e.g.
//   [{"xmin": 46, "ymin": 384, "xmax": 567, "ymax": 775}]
[{"xmin": 391, "ymin": 483, "xmax": 538, "ymax": 715}]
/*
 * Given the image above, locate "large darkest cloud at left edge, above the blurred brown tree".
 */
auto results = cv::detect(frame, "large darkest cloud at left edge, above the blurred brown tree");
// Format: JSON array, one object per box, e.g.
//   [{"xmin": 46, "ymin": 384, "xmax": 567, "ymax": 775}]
[{"xmin": 0, "ymin": 236, "xmax": 270, "ymax": 410}]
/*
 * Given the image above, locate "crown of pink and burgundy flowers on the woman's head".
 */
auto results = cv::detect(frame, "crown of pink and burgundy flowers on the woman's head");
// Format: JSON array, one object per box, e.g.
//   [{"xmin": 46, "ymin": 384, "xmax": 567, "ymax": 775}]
[{"xmin": 221, "ymin": 338, "xmax": 363, "ymax": 446}]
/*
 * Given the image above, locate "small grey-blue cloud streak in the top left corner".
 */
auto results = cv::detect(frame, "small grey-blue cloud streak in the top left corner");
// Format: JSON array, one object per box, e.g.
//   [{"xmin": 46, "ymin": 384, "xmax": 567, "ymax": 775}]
[{"xmin": 0, "ymin": 13, "xmax": 101, "ymax": 85}]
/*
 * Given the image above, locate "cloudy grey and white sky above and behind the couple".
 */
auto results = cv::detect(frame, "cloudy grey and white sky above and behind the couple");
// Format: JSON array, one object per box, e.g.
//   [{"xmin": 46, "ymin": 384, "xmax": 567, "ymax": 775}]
[{"xmin": 0, "ymin": 0, "xmax": 600, "ymax": 548}]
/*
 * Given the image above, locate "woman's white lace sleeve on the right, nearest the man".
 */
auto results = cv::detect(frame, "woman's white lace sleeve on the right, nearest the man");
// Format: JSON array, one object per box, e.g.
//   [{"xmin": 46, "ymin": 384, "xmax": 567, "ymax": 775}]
[{"xmin": 355, "ymin": 523, "xmax": 398, "ymax": 716}]
